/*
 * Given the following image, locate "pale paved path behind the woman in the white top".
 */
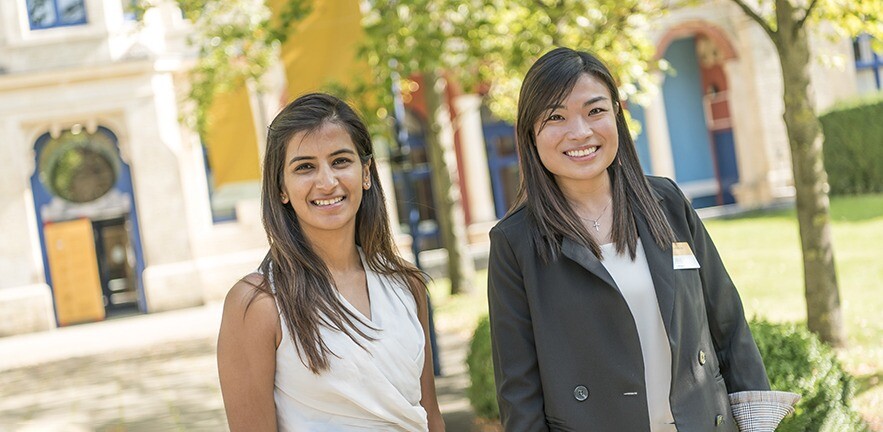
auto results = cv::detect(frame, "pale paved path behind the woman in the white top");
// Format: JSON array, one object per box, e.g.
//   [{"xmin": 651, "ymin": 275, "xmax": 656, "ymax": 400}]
[{"xmin": 0, "ymin": 304, "xmax": 472, "ymax": 432}]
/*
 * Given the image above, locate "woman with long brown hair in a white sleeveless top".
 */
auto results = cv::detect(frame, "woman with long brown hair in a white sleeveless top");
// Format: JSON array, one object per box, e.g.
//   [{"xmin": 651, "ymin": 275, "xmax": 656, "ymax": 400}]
[{"xmin": 218, "ymin": 93, "xmax": 444, "ymax": 432}]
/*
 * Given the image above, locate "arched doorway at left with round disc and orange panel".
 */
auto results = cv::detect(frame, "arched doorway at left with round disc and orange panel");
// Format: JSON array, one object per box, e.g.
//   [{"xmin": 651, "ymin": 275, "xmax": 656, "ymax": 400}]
[{"xmin": 30, "ymin": 125, "xmax": 146, "ymax": 325}]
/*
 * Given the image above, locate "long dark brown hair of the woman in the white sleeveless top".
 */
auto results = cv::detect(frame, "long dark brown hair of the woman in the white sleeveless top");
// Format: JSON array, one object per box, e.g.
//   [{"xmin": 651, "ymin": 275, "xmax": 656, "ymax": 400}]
[{"xmin": 252, "ymin": 93, "xmax": 426, "ymax": 374}]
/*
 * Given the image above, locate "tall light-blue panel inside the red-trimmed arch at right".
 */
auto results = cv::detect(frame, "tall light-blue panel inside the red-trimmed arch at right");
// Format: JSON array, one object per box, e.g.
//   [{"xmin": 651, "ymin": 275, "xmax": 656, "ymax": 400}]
[{"xmin": 662, "ymin": 38, "xmax": 715, "ymax": 183}]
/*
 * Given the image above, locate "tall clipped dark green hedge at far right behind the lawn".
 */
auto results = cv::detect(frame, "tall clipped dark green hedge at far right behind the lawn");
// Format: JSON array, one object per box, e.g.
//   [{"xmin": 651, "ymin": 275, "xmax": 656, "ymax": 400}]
[{"xmin": 819, "ymin": 97, "xmax": 883, "ymax": 195}]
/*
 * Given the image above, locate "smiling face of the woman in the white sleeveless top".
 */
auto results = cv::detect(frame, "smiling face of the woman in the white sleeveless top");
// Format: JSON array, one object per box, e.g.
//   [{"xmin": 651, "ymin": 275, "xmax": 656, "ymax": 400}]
[{"xmin": 281, "ymin": 122, "xmax": 371, "ymax": 239}]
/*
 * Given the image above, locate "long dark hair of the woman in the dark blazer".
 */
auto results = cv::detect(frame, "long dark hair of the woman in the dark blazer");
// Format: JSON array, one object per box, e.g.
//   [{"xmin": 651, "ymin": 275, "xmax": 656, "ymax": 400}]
[{"xmin": 513, "ymin": 48, "xmax": 674, "ymax": 262}]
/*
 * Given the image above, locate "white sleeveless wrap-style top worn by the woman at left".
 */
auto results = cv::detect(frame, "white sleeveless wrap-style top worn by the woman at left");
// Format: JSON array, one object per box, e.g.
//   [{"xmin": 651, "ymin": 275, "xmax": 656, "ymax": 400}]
[{"xmin": 270, "ymin": 250, "xmax": 428, "ymax": 432}]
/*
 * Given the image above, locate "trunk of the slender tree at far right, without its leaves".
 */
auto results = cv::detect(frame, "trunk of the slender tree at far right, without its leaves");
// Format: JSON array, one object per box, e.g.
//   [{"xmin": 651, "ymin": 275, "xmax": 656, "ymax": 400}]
[{"xmin": 773, "ymin": 0, "xmax": 846, "ymax": 347}]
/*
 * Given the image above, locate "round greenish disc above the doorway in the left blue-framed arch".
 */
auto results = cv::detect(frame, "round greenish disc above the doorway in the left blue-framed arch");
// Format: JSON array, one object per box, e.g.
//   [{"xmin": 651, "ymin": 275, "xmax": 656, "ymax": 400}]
[{"xmin": 40, "ymin": 131, "xmax": 118, "ymax": 203}]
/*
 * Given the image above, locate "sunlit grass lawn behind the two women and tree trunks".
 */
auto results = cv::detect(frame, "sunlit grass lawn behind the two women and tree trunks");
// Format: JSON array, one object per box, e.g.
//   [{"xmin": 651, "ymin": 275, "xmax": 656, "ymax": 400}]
[{"xmin": 431, "ymin": 195, "xmax": 883, "ymax": 431}]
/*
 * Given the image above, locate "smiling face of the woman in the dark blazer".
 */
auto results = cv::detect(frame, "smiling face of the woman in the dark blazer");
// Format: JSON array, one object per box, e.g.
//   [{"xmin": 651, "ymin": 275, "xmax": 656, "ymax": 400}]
[{"xmin": 534, "ymin": 74, "xmax": 619, "ymax": 196}]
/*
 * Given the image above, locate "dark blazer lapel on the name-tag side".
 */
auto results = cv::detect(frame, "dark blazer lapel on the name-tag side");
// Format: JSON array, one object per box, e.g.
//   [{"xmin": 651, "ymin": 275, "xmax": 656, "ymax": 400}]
[{"xmin": 635, "ymin": 211, "xmax": 677, "ymax": 334}]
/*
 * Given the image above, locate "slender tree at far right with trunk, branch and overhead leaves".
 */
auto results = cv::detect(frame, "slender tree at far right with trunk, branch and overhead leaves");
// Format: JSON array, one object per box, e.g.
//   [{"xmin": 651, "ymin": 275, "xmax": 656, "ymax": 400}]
[{"xmin": 731, "ymin": 0, "xmax": 883, "ymax": 346}]
